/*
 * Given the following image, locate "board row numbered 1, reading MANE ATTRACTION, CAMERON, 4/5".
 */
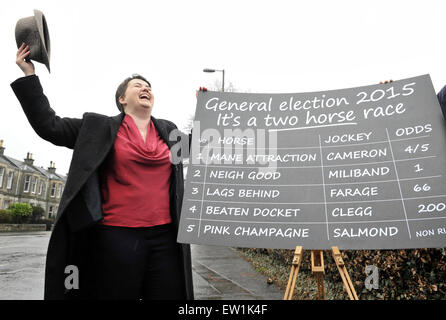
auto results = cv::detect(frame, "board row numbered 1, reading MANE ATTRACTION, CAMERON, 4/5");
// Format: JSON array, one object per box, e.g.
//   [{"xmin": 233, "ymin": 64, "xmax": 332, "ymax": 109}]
[{"xmin": 191, "ymin": 137, "xmax": 440, "ymax": 167}]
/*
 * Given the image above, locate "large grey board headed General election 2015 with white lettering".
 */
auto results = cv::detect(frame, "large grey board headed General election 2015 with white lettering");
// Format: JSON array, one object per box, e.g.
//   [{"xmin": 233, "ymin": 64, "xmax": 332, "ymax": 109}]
[{"xmin": 178, "ymin": 75, "xmax": 446, "ymax": 249}]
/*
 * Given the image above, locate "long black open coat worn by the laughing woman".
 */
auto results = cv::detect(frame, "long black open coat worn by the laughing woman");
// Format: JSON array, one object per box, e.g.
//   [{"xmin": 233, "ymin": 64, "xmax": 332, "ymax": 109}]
[{"xmin": 11, "ymin": 75, "xmax": 194, "ymax": 300}]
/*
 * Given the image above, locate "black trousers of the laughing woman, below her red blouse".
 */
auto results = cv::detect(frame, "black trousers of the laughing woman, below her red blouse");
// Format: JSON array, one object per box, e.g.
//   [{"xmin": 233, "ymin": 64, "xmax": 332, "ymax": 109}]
[{"xmin": 86, "ymin": 224, "xmax": 185, "ymax": 300}]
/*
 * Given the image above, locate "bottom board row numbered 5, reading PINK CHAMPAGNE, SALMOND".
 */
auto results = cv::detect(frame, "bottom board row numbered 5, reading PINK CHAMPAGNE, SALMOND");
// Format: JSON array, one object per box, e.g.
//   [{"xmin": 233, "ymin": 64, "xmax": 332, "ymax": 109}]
[{"xmin": 178, "ymin": 219, "xmax": 446, "ymax": 250}]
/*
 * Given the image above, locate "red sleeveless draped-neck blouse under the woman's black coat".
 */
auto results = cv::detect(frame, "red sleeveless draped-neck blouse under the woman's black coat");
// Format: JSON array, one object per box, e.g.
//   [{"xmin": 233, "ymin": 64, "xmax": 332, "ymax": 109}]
[{"xmin": 101, "ymin": 114, "xmax": 172, "ymax": 227}]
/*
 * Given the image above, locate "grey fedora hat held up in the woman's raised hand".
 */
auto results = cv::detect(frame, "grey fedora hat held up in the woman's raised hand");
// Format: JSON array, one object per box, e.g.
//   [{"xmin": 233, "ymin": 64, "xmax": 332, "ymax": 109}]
[{"xmin": 15, "ymin": 10, "xmax": 51, "ymax": 72}]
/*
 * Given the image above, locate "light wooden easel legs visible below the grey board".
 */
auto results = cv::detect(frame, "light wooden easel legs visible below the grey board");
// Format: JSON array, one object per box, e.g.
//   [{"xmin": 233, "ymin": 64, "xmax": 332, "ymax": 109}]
[{"xmin": 283, "ymin": 246, "xmax": 359, "ymax": 300}]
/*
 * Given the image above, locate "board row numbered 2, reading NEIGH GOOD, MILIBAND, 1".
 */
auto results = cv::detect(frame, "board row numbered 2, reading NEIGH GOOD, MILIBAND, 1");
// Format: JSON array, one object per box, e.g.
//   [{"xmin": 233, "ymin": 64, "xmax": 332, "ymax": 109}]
[{"xmin": 187, "ymin": 157, "xmax": 445, "ymax": 186}]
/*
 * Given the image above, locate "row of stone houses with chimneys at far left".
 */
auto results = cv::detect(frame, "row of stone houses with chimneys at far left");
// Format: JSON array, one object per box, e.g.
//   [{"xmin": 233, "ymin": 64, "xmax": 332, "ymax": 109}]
[{"xmin": 0, "ymin": 140, "xmax": 66, "ymax": 218}]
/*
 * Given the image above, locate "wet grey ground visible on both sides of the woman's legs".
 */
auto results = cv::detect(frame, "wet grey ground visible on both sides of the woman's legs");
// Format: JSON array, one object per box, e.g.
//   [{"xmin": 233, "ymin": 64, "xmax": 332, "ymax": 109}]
[{"xmin": 0, "ymin": 231, "xmax": 283, "ymax": 300}]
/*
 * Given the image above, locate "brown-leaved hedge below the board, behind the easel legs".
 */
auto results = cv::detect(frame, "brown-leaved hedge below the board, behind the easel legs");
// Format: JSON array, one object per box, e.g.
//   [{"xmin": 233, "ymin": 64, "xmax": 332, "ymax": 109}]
[{"xmin": 240, "ymin": 248, "xmax": 446, "ymax": 300}]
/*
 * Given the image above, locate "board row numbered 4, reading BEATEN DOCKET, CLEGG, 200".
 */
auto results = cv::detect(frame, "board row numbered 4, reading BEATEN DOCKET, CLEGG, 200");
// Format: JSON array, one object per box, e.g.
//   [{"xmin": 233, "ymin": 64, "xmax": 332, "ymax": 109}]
[{"xmin": 183, "ymin": 197, "xmax": 446, "ymax": 223}]
